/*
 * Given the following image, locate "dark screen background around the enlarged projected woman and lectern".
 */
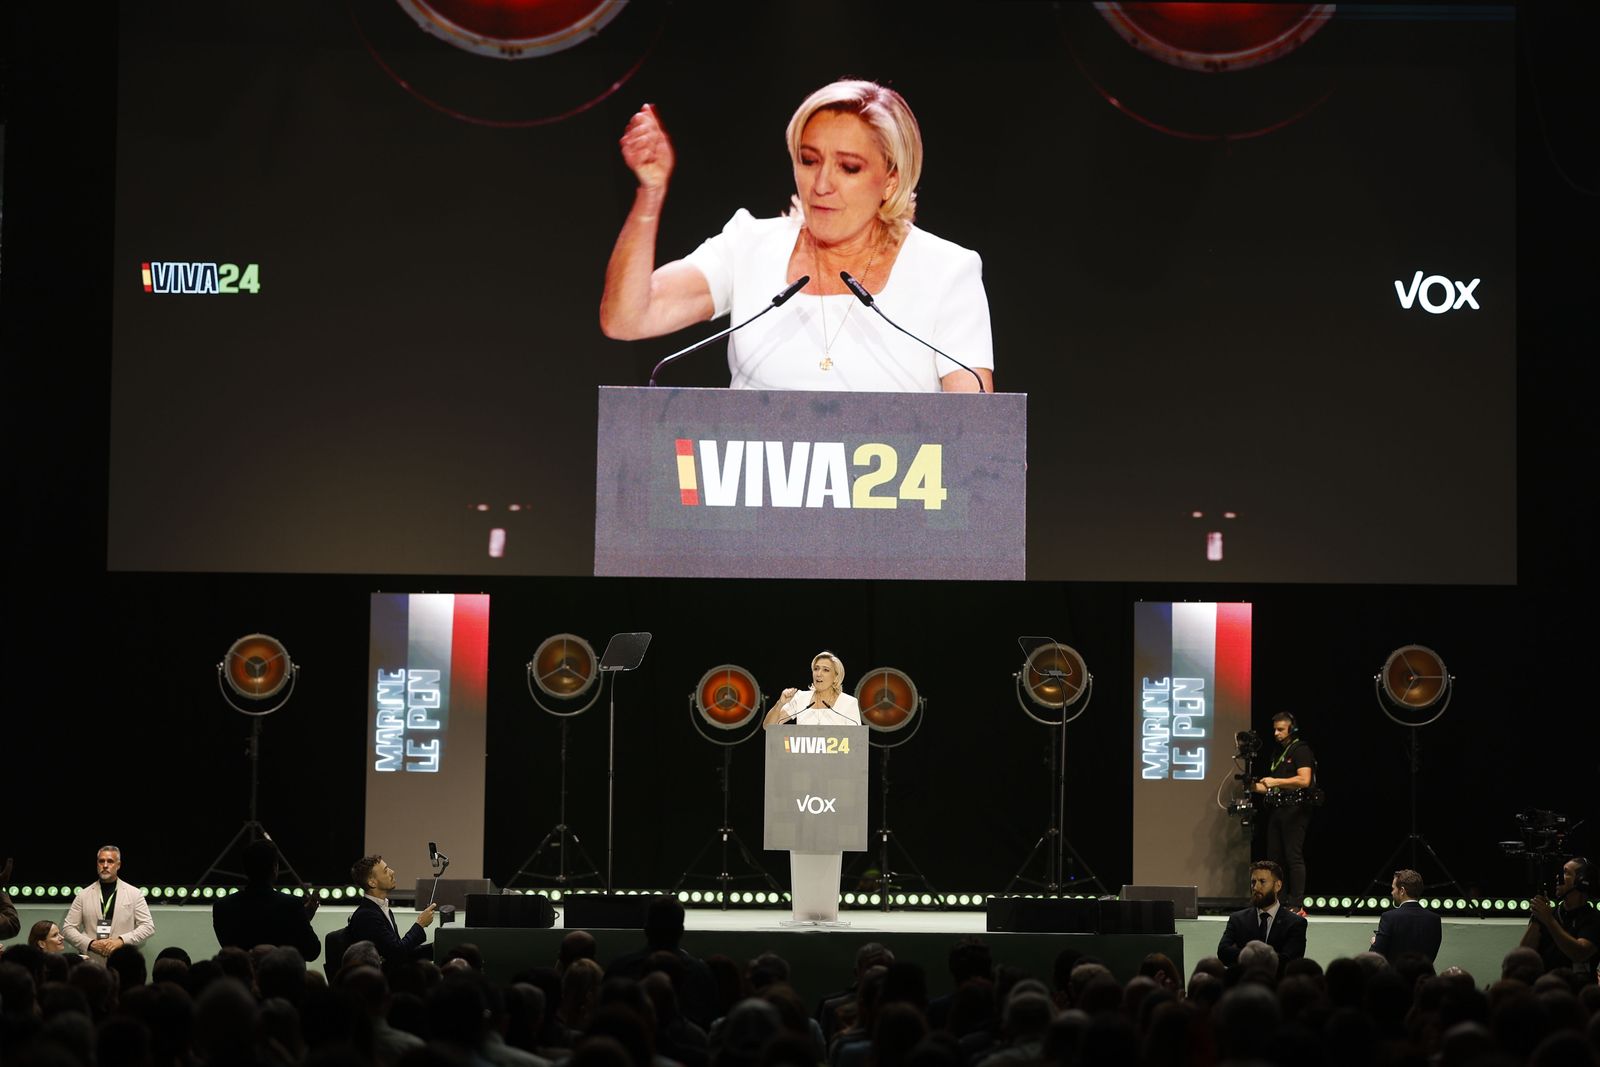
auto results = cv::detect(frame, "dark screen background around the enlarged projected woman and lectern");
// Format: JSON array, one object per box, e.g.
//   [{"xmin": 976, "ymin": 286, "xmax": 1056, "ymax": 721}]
[{"xmin": 109, "ymin": 0, "xmax": 1517, "ymax": 584}]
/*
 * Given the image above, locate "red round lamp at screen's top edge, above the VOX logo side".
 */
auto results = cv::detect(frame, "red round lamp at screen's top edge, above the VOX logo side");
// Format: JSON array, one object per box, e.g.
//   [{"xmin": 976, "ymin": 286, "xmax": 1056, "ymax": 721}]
[{"xmin": 1094, "ymin": 3, "xmax": 1336, "ymax": 74}]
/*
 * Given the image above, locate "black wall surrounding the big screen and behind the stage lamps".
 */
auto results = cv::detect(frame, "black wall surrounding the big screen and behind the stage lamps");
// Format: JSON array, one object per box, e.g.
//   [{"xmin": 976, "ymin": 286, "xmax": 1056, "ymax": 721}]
[{"xmin": 0, "ymin": 5, "xmax": 1600, "ymax": 893}]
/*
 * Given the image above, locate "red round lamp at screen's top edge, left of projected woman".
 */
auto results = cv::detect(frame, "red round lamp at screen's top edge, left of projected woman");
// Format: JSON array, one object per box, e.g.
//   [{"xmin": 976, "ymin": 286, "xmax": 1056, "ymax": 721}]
[{"xmin": 398, "ymin": 0, "xmax": 627, "ymax": 59}]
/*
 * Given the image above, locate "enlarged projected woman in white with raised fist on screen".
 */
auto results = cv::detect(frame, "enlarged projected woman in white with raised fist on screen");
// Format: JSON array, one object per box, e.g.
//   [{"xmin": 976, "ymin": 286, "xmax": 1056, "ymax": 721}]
[{"xmin": 600, "ymin": 80, "xmax": 994, "ymax": 392}]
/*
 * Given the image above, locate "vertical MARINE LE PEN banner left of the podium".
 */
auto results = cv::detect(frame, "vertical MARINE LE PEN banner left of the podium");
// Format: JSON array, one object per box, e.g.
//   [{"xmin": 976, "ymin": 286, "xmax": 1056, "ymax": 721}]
[{"xmin": 366, "ymin": 593, "xmax": 490, "ymax": 886}]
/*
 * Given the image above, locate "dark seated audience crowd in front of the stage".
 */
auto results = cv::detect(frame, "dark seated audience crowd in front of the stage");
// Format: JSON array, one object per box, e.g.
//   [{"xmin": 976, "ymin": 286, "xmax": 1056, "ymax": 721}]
[{"xmin": 0, "ymin": 849, "xmax": 1600, "ymax": 1067}]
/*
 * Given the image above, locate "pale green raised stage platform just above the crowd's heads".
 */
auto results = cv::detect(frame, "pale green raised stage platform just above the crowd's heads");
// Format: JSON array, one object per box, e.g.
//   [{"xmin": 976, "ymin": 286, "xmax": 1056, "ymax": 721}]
[{"xmin": 5, "ymin": 902, "xmax": 1526, "ymax": 997}]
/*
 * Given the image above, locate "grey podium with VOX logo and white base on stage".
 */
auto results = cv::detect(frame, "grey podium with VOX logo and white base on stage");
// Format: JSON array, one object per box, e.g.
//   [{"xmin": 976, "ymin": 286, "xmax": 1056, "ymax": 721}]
[{"xmin": 762, "ymin": 726, "xmax": 869, "ymax": 923}]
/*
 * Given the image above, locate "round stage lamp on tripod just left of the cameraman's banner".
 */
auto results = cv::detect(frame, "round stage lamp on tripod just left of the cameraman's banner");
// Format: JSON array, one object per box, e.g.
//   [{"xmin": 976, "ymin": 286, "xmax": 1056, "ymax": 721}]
[{"xmin": 1005, "ymin": 637, "xmax": 1107, "ymax": 894}]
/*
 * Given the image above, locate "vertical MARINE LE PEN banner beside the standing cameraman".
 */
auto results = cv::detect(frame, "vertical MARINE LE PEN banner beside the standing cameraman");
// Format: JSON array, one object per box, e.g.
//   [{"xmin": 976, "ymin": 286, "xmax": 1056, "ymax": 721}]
[{"xmin": 1133, "ymin": 603, "xmax": 1251, "ymax": 897}]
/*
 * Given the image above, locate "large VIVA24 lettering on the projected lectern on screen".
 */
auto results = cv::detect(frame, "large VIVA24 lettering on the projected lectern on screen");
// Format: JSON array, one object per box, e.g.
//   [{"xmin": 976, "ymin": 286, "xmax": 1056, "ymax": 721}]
[{"xmin": 674, "ymin": 437, "xmax": 950, "ymax": 512}]
